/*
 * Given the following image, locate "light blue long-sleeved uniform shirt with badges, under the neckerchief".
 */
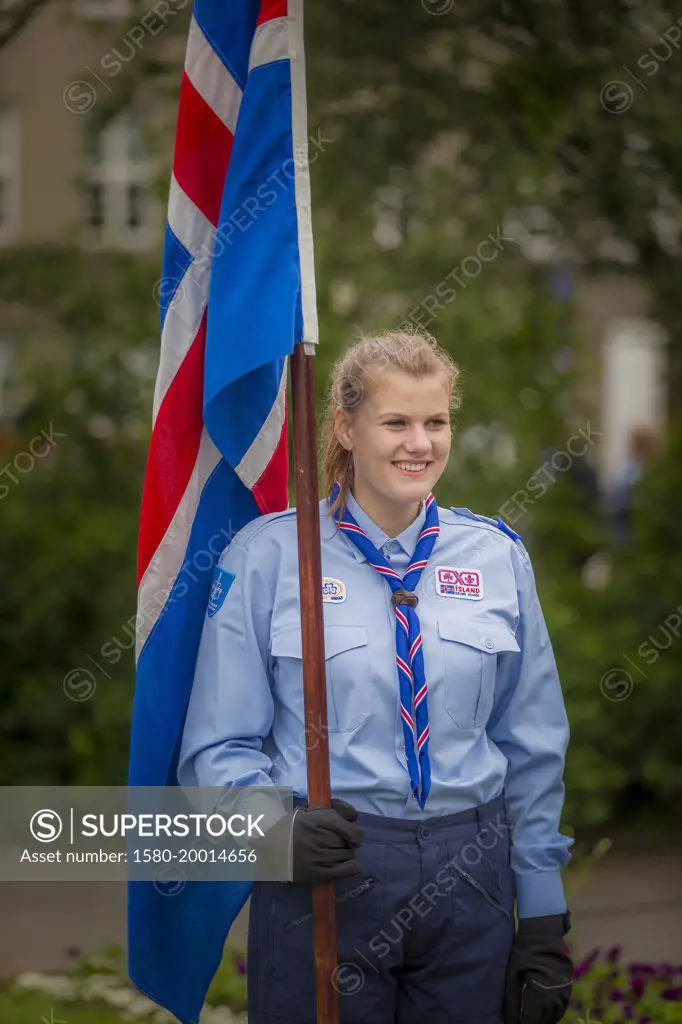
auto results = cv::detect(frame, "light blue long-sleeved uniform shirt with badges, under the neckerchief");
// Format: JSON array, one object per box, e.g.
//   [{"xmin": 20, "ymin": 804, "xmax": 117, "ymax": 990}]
[{"xmin": 178, "ymin": 495, "xmax": 572, "ymax": 916}]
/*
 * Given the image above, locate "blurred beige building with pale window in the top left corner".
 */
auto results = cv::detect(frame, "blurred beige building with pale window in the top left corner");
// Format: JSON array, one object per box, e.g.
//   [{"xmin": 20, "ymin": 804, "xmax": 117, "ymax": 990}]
[{"xmin": 0, "ymin": 0, "xmax": 173, "ymax": 251}]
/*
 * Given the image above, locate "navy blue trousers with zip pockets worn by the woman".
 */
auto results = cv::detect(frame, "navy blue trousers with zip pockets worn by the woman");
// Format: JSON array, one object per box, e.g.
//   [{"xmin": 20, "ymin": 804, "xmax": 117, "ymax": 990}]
[{"xmin": 248, "ymin": 797, "xmax": 514, "ymax": 1024}]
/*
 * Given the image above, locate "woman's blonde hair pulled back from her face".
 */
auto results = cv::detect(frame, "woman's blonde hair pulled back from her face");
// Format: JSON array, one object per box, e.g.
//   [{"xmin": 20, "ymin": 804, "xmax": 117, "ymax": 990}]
[{"xmin": 321, "ymin": 331, "xmax": 460, "ymax": 513}]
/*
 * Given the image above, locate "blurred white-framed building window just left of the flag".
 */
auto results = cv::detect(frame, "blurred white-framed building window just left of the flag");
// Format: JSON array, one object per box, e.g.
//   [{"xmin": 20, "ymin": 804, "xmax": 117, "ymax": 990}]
[{"xmin": 84, "ymin": 111, "xmax": 161, "ymax": 249}]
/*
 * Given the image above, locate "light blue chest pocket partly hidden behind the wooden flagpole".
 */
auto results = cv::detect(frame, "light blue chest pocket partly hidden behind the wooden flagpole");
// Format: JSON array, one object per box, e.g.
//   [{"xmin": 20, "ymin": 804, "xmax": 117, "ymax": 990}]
[{"xmin": 270, "ymin": 625, "xmax": 370, "ymax": 732}]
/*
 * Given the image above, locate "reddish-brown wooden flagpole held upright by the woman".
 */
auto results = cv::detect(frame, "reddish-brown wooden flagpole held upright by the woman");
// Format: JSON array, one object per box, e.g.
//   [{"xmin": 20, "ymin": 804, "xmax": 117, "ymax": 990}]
[{"xmin": 291, "ymin": 343, "xmax": 339, "ymax": 1024}]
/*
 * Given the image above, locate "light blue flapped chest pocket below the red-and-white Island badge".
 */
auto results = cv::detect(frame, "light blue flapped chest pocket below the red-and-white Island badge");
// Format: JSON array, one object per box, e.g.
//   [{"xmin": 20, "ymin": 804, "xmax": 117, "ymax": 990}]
[{"xmin": 438, "ymin": 618, "xmax": 520, "ymax": 729}]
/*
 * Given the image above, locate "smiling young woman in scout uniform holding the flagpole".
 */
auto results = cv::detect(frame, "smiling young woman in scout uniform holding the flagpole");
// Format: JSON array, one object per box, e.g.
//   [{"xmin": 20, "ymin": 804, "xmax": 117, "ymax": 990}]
[{"xmin": 178, "ymin": 332, "xmax": 572, "ymax": 1024}]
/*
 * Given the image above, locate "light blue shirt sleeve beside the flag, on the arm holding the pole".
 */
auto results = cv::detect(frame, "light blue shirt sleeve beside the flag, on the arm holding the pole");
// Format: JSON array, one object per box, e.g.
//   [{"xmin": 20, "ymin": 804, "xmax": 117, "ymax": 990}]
[{"xmin": 177, "ymin": 539, "xmax": 285, "ymax": 823}]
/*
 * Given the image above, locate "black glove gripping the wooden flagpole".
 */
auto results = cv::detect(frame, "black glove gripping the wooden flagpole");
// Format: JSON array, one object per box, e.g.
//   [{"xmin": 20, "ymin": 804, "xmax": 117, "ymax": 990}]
[{"xmin": 293, "ymin": 800, "xmax": 365, "ymax": 883}]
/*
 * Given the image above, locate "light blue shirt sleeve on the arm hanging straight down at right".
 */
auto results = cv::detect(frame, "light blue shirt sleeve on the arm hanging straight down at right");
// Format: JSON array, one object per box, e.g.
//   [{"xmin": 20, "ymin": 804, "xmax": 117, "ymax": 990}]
[{"xmin": 487, "ymin": 543, "xmax": 572, "ymax": 918}]
